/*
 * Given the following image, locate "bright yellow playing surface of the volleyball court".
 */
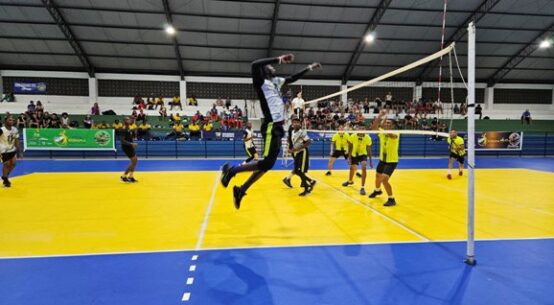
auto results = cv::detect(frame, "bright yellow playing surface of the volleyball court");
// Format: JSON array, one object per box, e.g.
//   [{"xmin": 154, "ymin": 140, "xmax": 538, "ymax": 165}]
[{"xmin": 0, "ymin": 169, "xmax": 554, "ymax": 257}]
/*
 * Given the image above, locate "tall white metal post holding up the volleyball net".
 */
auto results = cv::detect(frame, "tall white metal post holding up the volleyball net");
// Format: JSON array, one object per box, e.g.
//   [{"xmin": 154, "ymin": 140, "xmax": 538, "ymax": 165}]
[{"xmin": 465, "ymin": 22, "xmax": 477, "ymax": 266}]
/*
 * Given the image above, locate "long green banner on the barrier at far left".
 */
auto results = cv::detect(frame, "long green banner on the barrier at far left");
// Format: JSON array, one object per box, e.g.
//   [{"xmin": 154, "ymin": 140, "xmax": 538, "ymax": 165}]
[{"xmin": 23, "ymin": 128, "xmax": 115, "ymax": 151}]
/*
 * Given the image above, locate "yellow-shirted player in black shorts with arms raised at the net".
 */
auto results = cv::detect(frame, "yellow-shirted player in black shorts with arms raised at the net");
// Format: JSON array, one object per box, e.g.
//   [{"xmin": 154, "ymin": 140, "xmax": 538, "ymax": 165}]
[{"xmin": 369, "ymin": 110, "xmax": 400, "ymax": 207}]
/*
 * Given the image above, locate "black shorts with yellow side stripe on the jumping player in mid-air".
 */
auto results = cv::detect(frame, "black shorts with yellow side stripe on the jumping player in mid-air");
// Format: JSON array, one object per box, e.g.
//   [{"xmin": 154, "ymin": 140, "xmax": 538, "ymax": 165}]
[{"xmin": 258, "ymin": 122, "xmax": 285, "ymax": 171}]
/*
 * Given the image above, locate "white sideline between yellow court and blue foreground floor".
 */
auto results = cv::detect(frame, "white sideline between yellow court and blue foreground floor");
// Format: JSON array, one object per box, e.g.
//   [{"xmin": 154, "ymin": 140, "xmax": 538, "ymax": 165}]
[{"xmin": 0, "ymin": 236, "xmax": 554, "ymax": 260}]
